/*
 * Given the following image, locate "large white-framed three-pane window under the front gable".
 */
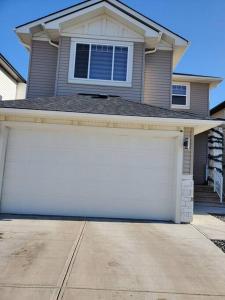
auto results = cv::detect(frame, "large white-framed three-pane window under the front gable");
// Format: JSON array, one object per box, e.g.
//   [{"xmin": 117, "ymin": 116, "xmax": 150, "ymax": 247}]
[{"xmin": 69, "ymin": 39, "xmax": 133, "ymax": 86}]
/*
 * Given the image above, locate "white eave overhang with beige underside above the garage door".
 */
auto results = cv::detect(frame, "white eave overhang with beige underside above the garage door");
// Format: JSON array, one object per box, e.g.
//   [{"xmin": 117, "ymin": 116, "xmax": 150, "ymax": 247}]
[{"xmin": 0, "ymin": 108, "xmax": 221, "ymax": 135}]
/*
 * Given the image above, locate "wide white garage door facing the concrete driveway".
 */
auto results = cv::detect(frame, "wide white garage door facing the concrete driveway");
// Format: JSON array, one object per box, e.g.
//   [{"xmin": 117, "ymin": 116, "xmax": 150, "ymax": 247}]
[{"xmin": 1, "ymin": 127, "xmax": 176, "ymax": 220}]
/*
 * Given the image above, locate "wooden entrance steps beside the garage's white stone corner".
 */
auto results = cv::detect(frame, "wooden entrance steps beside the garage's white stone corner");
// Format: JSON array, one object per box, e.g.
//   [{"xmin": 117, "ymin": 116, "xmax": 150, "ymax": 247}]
[{"xmin": 194, "ymin": 185, "xmax": 221, "ymax": 205}]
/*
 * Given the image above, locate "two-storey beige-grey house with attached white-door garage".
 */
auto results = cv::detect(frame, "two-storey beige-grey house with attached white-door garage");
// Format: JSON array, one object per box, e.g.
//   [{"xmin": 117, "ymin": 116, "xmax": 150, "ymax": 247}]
[{"xmin": 0, "ymin": 0, "xmax": 221, "ymax": 223}]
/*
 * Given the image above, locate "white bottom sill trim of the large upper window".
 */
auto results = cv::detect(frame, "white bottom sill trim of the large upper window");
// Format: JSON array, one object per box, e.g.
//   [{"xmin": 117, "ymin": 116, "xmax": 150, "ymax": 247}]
[{"xmin": 68, "ymin": 78, "xmax": 132, "ymax": 87}]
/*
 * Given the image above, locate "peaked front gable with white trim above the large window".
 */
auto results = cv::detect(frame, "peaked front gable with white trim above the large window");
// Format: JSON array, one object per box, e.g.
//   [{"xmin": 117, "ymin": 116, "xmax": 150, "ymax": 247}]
[{"xmin": 16, "ymin": 0, "xmax": 189, "ymax": 67}]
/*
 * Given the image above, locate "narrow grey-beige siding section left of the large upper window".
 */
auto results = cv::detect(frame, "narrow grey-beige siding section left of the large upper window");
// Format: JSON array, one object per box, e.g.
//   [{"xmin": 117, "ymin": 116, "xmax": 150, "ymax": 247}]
[{"xmin": 27, "ymin": 41, "xmax": 58, "ymax": 98}]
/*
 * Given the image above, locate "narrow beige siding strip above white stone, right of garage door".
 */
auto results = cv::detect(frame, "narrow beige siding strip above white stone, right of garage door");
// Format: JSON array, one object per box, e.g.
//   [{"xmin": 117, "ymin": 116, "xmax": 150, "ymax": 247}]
[{"xmin": 183, "ymin": 128, "xmax": 194, "ymax": 175}]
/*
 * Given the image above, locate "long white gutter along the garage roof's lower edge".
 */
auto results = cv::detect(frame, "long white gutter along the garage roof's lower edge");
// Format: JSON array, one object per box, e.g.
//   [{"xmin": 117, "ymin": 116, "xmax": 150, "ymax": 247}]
[{"xmin": 0, "ymin": 108, "xmax": 224, "ymax": 135}]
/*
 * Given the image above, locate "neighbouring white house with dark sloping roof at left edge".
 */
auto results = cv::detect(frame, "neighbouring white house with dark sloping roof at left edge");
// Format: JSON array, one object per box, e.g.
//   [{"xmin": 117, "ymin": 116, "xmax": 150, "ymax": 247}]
[{"xmin": 0, "ymin": 53, "xmax": 26, "ymax": 100}]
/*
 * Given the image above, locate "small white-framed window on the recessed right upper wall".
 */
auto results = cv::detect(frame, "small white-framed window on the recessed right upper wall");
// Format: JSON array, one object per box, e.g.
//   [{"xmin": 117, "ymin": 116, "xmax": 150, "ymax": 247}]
[{"xmin": 171, "ymin": 82, "xmax": 190, "ymax": 109}]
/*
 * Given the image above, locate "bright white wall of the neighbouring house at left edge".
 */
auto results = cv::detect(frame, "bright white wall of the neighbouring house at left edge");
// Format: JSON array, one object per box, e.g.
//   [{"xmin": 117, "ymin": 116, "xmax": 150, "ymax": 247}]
[{"xmin": 0, "ymin": 69, "xmax": 17, "ymax": 100}]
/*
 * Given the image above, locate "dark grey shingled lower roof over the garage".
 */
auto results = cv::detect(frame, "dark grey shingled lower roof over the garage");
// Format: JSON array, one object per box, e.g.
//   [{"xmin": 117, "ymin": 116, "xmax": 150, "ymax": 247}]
[{"xmin": 0, "ymin": 94, "xmax": 211, "ymax": 120}]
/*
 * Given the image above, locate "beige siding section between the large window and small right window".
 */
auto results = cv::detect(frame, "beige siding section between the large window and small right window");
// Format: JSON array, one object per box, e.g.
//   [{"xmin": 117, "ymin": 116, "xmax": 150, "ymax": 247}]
[{"xmin": 144, "ymin": 50, "xmax": 173, "ymax": 108}]
